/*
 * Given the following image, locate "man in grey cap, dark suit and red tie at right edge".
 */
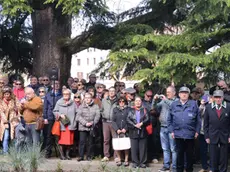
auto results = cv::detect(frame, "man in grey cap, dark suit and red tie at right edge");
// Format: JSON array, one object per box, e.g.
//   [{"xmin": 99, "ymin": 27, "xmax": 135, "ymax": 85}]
[{"xmin": 204, "ymin": 90, "xmax": 230, "ymax": 172}]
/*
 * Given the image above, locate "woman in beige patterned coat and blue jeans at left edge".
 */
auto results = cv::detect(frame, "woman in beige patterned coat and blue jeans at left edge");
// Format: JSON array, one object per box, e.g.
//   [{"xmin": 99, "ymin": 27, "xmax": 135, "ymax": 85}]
[{"xmin": 0, "ymin": 86, "xmax": 20, "ymax": 154}]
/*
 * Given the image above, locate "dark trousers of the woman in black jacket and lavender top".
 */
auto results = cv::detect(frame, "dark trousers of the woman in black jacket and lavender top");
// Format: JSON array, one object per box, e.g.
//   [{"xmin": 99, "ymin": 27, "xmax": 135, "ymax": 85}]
[{"xmin": 131, "ymin": 138, "xmax": 147, "ymax": 166}]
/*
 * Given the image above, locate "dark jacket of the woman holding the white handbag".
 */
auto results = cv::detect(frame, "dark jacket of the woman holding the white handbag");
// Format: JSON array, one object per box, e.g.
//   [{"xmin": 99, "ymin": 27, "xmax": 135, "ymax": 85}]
[{"xmin": 112, "ymin": 106, "xmax": 130, "ymax": 131}]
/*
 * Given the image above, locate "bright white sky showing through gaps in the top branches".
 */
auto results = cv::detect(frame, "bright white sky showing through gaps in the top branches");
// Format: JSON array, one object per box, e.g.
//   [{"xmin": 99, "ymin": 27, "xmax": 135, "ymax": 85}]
[{"xmin": 71, "ymin": 0, "xmax": 142, "ymax": 37}]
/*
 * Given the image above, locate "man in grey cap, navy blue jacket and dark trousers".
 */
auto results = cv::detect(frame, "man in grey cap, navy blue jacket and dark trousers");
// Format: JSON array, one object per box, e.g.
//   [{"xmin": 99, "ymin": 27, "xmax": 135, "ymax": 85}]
[{"xmin": 167, "ymin": 87, "xmax": 201, "ymax": 172}]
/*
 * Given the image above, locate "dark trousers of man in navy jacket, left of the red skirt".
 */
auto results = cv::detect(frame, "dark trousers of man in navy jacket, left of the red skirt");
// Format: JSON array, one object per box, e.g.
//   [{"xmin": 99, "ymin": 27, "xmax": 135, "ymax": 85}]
[{"xmin": 43, "ymin": 121, "xmax": 55, "ymax": 155}]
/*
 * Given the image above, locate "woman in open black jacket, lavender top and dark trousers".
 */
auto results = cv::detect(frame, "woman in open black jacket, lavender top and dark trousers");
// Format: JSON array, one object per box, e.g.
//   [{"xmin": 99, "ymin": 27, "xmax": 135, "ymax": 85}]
[{"xmin": 127, "ymin": 96, "xmax": 149, "ymax": 168}]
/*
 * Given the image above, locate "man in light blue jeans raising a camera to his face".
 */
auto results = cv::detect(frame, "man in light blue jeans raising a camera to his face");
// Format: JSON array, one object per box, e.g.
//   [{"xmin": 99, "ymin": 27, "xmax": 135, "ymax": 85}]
[{"xmin": 154, "ymin": 86, "xmax": 178, "ymax": 172}]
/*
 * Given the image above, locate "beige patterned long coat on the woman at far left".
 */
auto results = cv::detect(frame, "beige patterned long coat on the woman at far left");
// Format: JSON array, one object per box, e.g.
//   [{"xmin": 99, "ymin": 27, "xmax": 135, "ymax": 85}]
[{"xmin": 0, "ymin": 99, "xmax": 20, "ymax": 141}]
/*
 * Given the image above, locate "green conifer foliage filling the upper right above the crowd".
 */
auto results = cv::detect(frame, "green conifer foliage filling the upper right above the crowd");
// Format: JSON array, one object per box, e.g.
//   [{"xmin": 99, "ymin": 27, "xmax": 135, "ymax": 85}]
[{"xmin": 102, "ymin": 0, "xmax": 230, "ymax": 84}]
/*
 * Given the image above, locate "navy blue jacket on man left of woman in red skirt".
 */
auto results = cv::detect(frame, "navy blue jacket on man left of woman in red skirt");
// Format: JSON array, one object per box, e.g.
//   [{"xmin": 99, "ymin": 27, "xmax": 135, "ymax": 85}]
[{"xmin": 43, "ymin": 91, "xmax": 62, "ymax": 121}]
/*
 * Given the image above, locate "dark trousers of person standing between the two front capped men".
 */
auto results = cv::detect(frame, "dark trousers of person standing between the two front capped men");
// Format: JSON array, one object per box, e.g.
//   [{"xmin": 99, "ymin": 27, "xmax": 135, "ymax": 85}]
[{"xmin": 199, "ymin": 134, "xmax": 208, "ymax": 170}]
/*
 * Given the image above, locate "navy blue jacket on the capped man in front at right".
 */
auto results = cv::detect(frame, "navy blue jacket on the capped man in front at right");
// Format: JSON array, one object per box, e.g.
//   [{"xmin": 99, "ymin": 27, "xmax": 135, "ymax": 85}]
[{"xmin": 167, "ymin": 100, "xmax": 201, "ymax": 139}]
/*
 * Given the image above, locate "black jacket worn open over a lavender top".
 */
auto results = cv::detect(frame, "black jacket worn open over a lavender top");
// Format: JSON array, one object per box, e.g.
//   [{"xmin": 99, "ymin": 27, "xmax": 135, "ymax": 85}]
[{"xmin": 127, "ymin": 108, "xmax": 149, "ymax": 139}]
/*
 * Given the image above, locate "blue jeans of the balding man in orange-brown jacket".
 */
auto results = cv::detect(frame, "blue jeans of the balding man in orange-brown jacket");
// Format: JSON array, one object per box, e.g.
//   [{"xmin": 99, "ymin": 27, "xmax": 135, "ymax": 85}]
[{"xmin": 25, "ymin": 124, "xmax": 40, "ymax": 146}]
